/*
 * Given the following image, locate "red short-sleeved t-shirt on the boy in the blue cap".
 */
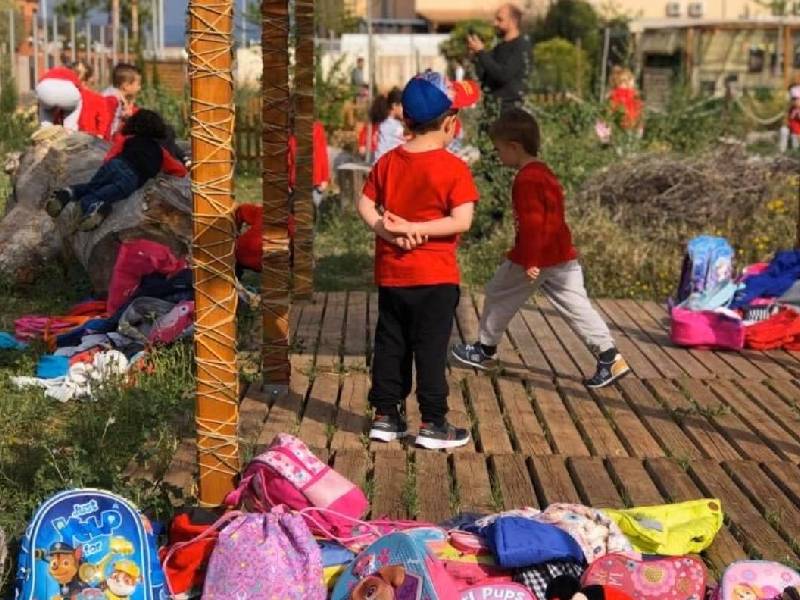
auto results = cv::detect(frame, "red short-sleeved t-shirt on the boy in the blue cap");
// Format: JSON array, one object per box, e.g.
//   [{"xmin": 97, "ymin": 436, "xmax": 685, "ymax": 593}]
[{"xmin": 364, "ymin": 146, "xmax": 478, "ymax": 287}]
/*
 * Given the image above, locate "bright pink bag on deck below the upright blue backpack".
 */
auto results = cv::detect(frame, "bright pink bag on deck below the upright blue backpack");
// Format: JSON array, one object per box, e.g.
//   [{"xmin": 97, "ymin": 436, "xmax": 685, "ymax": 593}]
[{"xmin": 670, "ymin": 306, "xmax": 744, "ymax": 350}]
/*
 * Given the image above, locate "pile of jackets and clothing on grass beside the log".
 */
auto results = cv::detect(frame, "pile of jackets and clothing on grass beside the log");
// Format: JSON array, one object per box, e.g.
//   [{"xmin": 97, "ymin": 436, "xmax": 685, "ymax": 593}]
[{"xmin": 5, "ymin": 240, "xmax": 194, "ymax": 402}]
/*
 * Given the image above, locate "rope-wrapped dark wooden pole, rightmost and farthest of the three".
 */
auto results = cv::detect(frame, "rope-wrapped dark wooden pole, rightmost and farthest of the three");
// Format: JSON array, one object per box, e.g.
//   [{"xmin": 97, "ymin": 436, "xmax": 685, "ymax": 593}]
[{"xmin": 292, "ymin": 0, "xmax": 314, "ymax": 299}]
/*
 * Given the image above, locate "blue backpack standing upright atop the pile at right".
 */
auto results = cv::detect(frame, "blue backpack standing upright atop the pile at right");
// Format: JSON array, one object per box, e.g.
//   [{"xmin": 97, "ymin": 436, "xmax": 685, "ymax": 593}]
[{"xmin": 677, "ymin": 235, "xmax": 734, "ymax": 303}]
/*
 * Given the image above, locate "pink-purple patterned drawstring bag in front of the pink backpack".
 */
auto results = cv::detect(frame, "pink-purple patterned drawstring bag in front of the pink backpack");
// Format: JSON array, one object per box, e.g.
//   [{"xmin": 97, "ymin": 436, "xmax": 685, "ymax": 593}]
[{"xmin": 202, "ymin": 509, "xmax": 327, "ymax": 600}]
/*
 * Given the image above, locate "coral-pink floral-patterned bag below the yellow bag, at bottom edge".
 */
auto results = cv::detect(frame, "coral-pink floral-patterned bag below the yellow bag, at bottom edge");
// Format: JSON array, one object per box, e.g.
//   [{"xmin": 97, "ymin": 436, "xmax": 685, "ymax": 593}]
[{"xmin": 581, "ymin": 552, "xmax": 706, "ymax": 600}]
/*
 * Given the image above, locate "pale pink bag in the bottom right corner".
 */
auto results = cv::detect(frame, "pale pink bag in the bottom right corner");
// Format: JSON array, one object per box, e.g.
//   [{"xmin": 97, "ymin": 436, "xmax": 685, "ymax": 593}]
[{"xmin": 713, "ymin": 560, "xmax": 800, "ymax": 600}]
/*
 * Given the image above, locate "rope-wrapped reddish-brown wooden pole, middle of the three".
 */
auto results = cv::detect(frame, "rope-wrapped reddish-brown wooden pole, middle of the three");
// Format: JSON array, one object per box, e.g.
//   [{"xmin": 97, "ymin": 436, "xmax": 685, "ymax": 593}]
[{"xmin": 261, "ymin": 0, "xmax": 291, "ymax": 385}]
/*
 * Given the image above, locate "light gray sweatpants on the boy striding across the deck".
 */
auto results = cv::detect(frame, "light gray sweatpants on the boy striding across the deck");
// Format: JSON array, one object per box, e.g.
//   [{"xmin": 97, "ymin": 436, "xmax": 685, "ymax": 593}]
[{"xmin": 480, "ymin": 260, "xmax": 614, "ymax": 354}]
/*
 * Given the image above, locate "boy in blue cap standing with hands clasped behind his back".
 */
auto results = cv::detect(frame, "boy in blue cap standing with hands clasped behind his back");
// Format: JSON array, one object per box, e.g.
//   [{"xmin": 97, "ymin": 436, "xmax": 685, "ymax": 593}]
[{"xmin": 358, "ymin": 73, "xmax": 478, "ymax": 449}]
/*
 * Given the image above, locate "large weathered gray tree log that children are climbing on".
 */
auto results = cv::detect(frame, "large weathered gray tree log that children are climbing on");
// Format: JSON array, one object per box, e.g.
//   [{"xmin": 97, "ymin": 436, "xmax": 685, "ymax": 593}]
[{"xmin": 0, "ymin": 127, "xmax": 192, "ymax": 293}]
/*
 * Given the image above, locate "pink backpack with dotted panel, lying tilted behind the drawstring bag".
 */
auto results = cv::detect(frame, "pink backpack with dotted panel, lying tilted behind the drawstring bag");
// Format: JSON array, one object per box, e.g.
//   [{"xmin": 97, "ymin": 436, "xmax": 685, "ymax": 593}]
[{"xmin": 225, "ymin": 433, "xmax": 369, "ymax": 540}]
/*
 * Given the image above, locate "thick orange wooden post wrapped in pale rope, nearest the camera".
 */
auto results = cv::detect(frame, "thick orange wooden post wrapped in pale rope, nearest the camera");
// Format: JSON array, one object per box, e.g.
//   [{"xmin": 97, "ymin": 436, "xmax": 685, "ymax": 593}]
[{"xmin": 189, "ymin": 0, "xmax": 239, "ymax": 506}]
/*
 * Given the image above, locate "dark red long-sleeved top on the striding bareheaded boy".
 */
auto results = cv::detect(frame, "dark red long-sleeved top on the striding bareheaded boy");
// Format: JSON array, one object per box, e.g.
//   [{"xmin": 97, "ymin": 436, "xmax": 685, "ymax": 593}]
[{"xmin": 508, "ymin": 161, "xmax": 578, "ymax": 269}]
